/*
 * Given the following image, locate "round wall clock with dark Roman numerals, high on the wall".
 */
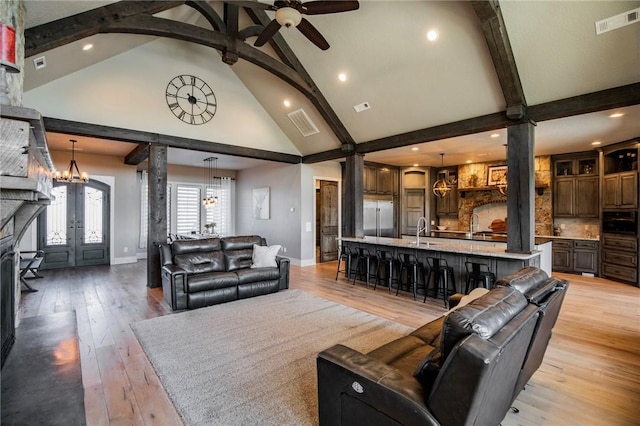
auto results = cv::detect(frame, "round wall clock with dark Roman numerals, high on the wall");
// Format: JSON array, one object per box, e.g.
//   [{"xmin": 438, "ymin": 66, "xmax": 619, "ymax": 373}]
[{"xmin": 166, "ymin": 74, "xmax": 217, "ymax": 125}]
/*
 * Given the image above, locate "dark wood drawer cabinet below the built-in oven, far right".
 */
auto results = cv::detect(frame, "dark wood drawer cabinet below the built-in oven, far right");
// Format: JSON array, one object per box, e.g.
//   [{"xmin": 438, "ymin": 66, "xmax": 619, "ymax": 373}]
[{"xmin": 602, "ymin": 234, "xmax": 640, "ymax": 286}]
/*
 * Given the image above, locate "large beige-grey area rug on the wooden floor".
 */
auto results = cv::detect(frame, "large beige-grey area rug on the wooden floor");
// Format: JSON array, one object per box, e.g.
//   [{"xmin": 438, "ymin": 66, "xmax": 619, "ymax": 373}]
[{"xmin": 131, "ymin": 290, "xmax": 410, "ymax": 426}]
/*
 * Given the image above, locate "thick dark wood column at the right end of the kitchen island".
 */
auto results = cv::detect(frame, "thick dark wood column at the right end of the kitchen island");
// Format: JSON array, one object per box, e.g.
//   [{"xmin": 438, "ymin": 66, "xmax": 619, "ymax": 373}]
[{"xmin": 507, "ymin": 122, "xmax": 535, "ymax": 253}]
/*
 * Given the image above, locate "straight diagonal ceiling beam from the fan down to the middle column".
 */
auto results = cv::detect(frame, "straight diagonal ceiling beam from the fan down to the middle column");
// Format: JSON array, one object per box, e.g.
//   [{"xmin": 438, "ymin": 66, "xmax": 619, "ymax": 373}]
[{"xmin": 245, "ymin": 8, "xmax": 355, "ymax": 144}]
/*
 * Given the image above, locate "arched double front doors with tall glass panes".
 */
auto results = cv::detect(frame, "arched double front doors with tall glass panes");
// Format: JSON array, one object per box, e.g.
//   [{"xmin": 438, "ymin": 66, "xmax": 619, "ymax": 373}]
[{"xmin": 38, "ymin": 180, "xmax": 111, "ymax": 269}]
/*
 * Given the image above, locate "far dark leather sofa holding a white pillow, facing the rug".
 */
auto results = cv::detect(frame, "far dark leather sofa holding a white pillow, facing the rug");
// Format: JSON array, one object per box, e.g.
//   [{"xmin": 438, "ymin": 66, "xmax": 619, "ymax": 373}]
[{"xmin": 160, "ymin": 235, "xmax": 289, "ymax": 310}]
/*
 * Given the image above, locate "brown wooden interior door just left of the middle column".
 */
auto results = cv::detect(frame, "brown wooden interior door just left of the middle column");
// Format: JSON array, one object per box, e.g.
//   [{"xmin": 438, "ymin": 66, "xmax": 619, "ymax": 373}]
[{"xmin": 317, "ymin": 180, "xmax": 339, "ymax": 262}]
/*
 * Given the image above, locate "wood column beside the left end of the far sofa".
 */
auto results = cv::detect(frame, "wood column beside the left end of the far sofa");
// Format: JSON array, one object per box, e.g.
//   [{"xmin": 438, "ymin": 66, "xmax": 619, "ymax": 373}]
[{"xmin": 147, "ymin": 144, "xmax": 167, "ymax": 287}]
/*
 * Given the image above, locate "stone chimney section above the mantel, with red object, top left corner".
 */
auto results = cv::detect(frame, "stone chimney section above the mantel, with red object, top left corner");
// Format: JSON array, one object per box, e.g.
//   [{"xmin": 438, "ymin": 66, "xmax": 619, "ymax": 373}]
[{"xmin": 0, "ymin": 0, "xmax": 26, "ymax": 108}]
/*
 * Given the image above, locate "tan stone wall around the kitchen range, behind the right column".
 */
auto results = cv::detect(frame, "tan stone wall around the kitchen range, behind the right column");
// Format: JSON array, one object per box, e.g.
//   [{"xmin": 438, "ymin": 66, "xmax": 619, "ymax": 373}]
[{"xmin": 458, "ymin": 156, "xmax": 553, "ymax": 235}]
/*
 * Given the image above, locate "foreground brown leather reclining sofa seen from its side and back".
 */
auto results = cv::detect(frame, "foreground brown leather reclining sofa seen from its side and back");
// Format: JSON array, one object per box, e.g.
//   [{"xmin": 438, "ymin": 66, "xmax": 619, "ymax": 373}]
[{"xmin": 317, "ymin": 267, "xmax": 568, "ymax": 426}]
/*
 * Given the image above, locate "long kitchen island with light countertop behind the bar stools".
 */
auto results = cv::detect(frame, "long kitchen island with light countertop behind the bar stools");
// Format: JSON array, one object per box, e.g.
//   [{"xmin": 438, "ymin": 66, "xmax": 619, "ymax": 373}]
[{"xmin": 340, "ymin": 236, "xmax": 551, "ymax": 293}]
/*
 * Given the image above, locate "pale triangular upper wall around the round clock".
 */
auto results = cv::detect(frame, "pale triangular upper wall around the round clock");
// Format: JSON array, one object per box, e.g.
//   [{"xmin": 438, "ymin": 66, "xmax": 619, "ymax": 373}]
[{"xmin": 23, "ymin": 38, "xmax": 300, "ymax": 155}]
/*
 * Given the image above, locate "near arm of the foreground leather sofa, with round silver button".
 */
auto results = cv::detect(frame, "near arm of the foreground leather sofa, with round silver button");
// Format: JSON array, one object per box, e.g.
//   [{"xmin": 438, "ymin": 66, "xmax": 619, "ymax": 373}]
[{"xmin": 317, "ymin": 345, "xmax": 439, "ymax": 426}]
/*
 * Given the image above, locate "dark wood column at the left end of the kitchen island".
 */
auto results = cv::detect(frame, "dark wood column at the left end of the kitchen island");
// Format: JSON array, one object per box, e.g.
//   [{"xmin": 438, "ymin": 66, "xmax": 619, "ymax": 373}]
[{"xmin": 342, "ymin": 154, "xmax": 364, "ymax": 237}]
